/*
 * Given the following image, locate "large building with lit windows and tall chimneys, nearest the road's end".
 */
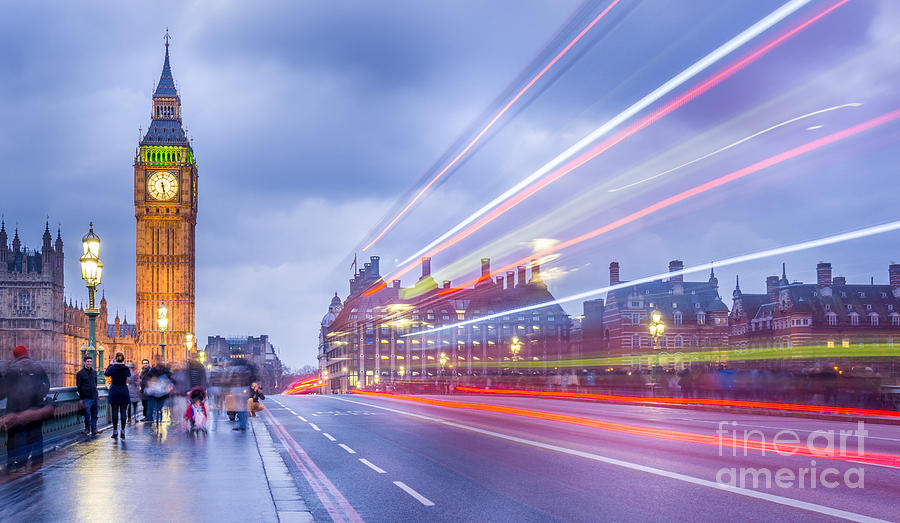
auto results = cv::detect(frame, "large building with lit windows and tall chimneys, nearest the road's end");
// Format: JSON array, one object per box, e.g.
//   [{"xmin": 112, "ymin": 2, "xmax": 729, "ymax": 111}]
[{"xmin": 319, "ymin": 256, "xmax": 572, "ymax": 392}]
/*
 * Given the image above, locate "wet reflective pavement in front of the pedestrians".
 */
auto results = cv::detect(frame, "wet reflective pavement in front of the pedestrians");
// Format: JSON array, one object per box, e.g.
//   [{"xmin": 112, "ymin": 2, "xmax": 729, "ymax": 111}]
[{"xmin": 0, "ymin": 412, "xmax": 278, "ymax": 521}]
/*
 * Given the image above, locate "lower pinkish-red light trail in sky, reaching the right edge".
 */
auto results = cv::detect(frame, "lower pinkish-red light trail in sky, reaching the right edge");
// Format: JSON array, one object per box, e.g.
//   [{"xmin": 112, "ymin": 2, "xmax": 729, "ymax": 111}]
[{"xmin": 432, "ymin": 109, "xmax": 900, "ymax": 294}]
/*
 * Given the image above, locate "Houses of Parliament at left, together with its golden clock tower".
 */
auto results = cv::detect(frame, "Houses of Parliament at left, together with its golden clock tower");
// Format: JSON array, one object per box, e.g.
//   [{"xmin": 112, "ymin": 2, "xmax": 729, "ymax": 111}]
[{"xmin": 0, "ymin": 35, "xmax": 198, "ymax": 387}]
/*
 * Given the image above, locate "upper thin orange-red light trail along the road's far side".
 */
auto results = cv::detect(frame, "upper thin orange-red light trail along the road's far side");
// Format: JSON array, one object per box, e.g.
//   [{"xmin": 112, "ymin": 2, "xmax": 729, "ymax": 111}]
[{"xmin": 456, "ymin": 386, "xmax": 900, "ymax": 418}]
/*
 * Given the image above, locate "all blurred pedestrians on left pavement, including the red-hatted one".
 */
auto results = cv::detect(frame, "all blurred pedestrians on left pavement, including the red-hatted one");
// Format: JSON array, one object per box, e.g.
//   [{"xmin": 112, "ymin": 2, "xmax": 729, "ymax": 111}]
[{"xmin": 0, "ymin": 345, "xmax": 265, "ymax": 472}]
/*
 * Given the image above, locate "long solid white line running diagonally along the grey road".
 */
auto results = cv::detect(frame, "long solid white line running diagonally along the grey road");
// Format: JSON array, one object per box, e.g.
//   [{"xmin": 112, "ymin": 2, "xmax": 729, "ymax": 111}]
[{"xmin": 328, "ymin": 396, "xmax": 885, "ymax": 521}]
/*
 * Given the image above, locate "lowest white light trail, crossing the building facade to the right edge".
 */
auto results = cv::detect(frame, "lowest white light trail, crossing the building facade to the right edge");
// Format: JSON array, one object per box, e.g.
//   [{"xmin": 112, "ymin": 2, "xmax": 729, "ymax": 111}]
[{"xmin": 403, "ymin": 220, "xmax": 900, "ymax": 337}]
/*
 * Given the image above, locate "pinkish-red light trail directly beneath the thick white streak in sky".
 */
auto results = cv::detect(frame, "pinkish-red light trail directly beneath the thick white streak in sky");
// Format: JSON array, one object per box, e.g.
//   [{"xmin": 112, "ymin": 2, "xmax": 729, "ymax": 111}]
[{"xmin": 363, "ymin": 0, "xmax": 850, "ymax": 296}]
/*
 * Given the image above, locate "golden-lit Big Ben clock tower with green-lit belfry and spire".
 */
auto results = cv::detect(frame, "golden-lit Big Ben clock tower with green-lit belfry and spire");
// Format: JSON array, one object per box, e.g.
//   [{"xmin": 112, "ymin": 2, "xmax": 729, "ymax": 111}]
[{"xmin": 134, "ymin": 34, "xmax": 197, "ymax": 361}]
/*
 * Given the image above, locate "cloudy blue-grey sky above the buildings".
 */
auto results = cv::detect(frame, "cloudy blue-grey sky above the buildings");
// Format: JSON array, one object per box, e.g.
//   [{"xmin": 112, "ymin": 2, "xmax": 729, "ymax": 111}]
[{"xmin": 0, "ymin": 0, "xmax": 900, "ymax": 366}]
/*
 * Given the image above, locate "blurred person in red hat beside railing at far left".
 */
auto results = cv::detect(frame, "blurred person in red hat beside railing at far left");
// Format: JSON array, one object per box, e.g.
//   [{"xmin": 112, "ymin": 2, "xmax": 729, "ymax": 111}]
[{"xmin": 0, "ymin": 345, "xmax": 53, "ymax": 472}]
